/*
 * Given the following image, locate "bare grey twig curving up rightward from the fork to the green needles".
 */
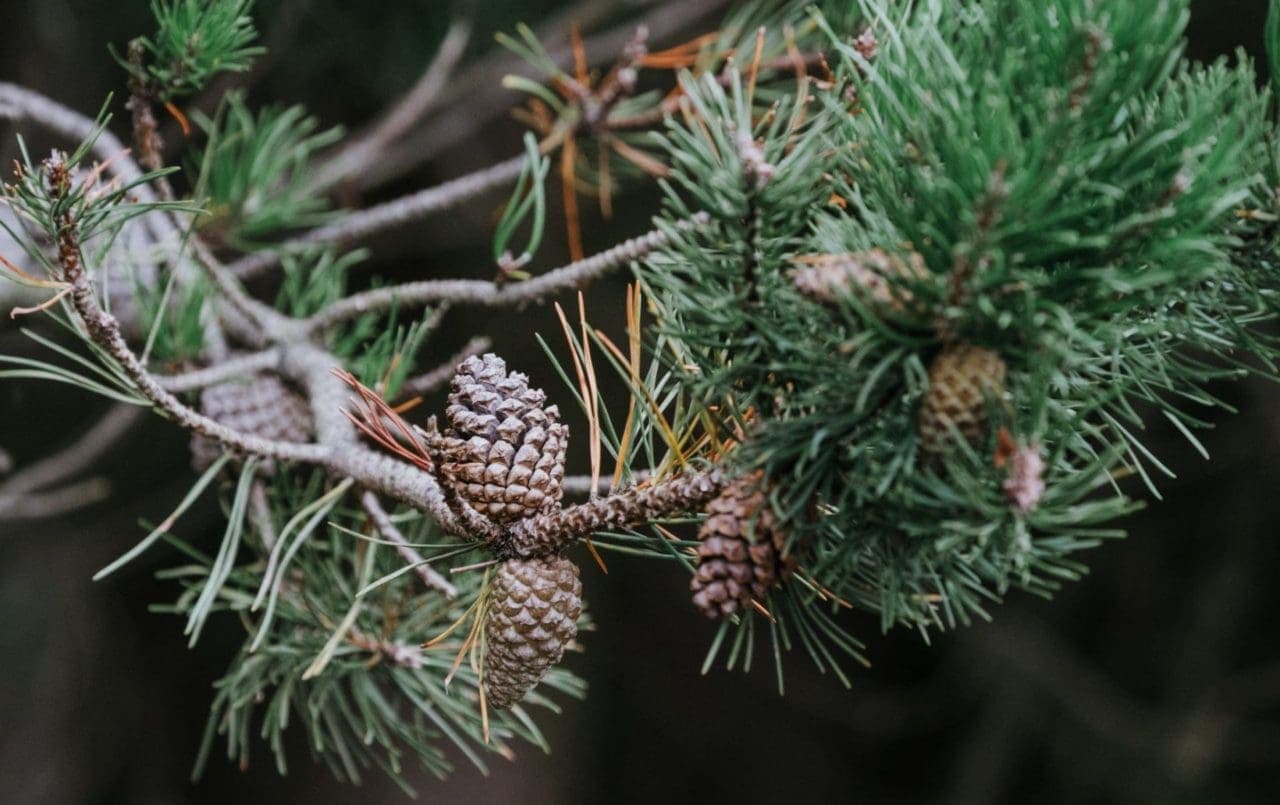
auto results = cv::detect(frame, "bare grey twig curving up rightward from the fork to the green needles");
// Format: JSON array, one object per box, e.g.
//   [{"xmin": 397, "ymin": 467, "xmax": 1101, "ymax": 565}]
[{"xmin": 303, "ymin": 212, "xmax": 708, "ymax": 333}]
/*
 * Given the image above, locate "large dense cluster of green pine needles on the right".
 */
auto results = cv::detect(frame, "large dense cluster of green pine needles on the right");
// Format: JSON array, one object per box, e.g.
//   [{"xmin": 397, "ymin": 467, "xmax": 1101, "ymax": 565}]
[{"xmin": 640, "ymin": 0, "xmax": 1275, "ymax": 647}]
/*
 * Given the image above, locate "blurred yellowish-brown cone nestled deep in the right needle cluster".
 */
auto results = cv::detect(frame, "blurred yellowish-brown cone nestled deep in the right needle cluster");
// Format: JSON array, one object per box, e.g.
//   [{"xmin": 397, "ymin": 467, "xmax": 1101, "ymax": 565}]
[{"xmin": 920, "ymin": 344, "xmax": 1006, "ymax": 456}]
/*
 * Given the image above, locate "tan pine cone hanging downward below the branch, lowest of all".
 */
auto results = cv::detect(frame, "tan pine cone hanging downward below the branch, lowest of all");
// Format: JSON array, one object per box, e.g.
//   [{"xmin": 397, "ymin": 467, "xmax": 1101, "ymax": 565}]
[{"xmin": 485, "ymin": 557, "xmax": 582, "ymax": 710}]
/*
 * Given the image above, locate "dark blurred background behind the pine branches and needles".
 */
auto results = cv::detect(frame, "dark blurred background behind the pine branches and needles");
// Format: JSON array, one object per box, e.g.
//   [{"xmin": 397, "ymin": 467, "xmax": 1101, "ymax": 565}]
[{"xmin": 0, "ymin": 0, "xmax": 1280, "ymax": 805}]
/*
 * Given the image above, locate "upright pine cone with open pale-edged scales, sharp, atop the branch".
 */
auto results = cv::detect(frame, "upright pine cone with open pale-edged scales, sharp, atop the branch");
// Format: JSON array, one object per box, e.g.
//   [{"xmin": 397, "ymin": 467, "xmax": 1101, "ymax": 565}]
[{"xmin": 438, "ymin": 355, "xmax": 568, "ymax": 522}]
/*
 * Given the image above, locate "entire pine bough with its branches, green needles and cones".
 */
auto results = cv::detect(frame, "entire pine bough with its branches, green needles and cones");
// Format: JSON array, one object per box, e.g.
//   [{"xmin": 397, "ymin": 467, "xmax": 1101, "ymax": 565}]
[{"xmin": 0, "ymin": 0, "xmax": 1280, "ymax": 785}]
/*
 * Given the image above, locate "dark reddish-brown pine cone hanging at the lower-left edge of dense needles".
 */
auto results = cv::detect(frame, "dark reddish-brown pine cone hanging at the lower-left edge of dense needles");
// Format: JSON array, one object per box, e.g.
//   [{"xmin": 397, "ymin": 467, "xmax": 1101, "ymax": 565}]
[{"xmin": 689, "ymin": 472, "xmax": 795, "ymax": 618}]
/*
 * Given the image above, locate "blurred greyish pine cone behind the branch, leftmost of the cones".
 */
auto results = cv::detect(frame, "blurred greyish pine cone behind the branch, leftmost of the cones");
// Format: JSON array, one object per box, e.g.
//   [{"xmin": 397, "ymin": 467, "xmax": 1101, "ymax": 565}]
[{"xmin": 191, "ymin": 374, "xmax": 311, "ymax": 474}]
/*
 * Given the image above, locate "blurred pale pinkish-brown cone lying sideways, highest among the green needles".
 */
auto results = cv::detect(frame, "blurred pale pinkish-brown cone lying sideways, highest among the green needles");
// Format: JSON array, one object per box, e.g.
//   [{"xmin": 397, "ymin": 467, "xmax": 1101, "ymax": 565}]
[{"xmin": 790, "ymin": 248, "xmax": 928, "ymax": 312}]
